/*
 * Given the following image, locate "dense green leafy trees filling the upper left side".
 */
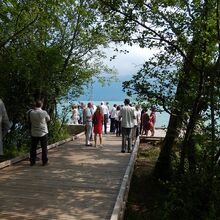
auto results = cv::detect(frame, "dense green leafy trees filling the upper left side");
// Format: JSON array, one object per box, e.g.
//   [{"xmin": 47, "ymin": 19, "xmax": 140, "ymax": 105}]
[{"xmin": 0, "ymin": 0, "xmax": 116, "ymax": 150}]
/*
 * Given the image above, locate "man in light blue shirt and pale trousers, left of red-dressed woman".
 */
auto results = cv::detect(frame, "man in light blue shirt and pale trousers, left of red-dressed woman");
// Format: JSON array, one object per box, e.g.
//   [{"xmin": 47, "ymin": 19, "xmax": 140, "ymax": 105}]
[{"xmin": 84, "ymin": 102, "xmax": 93, "ymax": 146}]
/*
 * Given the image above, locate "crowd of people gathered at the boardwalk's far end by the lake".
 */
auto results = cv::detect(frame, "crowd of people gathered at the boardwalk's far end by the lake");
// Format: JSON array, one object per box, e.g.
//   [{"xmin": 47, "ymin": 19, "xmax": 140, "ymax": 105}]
[{"xmin": 71, "ymin": 99, "xmax": 156, "ymax": 152}]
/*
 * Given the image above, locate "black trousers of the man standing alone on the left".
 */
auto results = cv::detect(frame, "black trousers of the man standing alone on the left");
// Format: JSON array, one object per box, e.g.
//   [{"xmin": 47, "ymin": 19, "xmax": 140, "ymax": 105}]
[{"xmin": 30, "ymin": 134, "xmax": 48, "ymax": 164}]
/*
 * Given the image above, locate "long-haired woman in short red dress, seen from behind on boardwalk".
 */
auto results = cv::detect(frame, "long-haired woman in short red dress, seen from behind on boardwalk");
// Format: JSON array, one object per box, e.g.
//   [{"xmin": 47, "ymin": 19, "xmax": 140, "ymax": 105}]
[{"xmin": 93, "ymin": 106, "xmax": 104, "ymax": 147}]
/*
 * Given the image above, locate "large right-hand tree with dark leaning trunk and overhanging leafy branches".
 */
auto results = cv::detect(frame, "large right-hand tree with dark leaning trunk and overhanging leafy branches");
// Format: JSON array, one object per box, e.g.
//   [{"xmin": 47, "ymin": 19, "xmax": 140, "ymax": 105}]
[{"xmin": 100, "ymin": 0, "xmax": 218, "ymax": 178}]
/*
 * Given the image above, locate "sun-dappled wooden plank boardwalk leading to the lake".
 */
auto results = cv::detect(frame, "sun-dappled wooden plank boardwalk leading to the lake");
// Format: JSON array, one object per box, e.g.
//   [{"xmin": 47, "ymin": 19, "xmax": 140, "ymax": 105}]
[{"xmin": 0, "ymin": 135, "xmax": 131, "ymax": 220}]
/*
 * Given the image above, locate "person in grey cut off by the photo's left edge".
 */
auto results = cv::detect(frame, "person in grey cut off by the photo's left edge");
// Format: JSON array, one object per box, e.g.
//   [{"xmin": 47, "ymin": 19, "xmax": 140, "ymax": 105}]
[{"xmin": 0, "ymin": 99, "xmax": 10, "ymax": 160}]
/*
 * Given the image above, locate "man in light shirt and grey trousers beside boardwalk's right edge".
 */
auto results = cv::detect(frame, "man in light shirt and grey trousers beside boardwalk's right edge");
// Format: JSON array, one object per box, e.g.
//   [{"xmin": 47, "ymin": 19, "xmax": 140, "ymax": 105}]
[{"xmin": 119, "ymin": 99, "xmax": 135, "ymax": 153}]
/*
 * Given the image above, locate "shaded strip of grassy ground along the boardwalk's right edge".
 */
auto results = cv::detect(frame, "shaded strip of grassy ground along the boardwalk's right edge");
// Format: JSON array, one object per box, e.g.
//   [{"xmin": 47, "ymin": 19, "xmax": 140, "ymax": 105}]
[{"xmin": 124, "ymin": 143, "xmax": 168, "ymax": 220}]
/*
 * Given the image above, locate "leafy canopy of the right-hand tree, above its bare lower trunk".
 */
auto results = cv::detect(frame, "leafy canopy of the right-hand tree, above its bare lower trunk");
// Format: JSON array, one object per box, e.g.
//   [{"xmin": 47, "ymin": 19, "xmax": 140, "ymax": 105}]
[{"xmin": 100, "ymin": 0, "xmax": 218, "ymax": 112}]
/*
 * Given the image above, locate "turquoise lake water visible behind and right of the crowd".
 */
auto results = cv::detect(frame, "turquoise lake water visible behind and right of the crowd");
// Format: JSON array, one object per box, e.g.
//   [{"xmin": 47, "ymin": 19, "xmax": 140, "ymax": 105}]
[{"xmin": 69, "ymin": 100, "xmax": 169, "ymax": 128}]
